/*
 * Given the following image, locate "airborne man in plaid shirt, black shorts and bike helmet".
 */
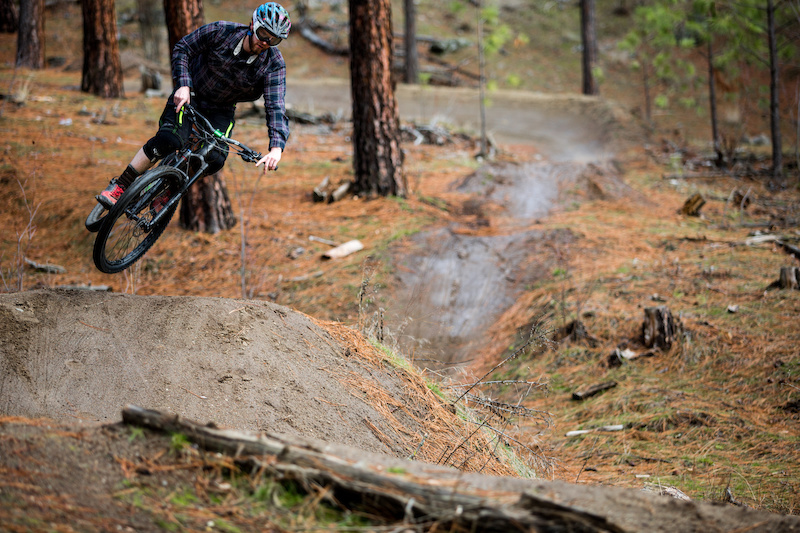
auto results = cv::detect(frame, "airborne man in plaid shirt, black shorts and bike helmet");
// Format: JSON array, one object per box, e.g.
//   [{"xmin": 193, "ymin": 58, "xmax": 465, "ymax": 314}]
[{"xmin": 96, "ymin": 2, "xmax": 292, "ymax": 209}]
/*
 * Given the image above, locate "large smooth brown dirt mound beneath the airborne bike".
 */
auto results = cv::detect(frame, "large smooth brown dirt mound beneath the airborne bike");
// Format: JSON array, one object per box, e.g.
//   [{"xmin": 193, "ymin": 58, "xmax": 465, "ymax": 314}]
[{"xmin": 0, "ymin": 290, "xmax": 450, "ymax": 456}]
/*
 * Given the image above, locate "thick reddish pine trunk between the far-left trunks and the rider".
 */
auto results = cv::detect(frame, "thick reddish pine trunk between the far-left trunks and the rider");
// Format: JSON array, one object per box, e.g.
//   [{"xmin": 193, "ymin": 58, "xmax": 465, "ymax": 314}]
[{"xmin": 81, "ymin": 0, "xmax": 124, "ymax": 98}]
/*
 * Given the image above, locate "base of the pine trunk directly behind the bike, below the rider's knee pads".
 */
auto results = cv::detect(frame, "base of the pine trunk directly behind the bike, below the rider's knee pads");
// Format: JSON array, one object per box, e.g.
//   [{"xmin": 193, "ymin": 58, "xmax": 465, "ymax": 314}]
[{"xmin": 180, "ymin": 172, "xmax": 236, "ymax": 233}]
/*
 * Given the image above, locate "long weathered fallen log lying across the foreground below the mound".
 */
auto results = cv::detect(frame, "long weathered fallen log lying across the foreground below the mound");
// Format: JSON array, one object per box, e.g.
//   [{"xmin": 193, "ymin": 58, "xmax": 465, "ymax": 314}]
[{"xmin": 122, "ymin": 405, "xmax": 624, "ymax": 533}]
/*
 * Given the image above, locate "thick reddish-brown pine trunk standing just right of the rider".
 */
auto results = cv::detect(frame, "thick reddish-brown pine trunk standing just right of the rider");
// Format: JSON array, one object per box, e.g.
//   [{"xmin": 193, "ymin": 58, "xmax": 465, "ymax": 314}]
[{"xmin": 350, "ymin": 0, "xmax": 407, "ymax": 196}]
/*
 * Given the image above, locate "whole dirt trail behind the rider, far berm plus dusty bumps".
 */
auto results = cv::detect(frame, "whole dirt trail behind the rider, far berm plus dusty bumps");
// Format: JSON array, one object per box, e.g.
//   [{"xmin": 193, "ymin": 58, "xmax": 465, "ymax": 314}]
[{"xmin": 287, "ymin": 80, "xmax": 629, "ymax": 364}]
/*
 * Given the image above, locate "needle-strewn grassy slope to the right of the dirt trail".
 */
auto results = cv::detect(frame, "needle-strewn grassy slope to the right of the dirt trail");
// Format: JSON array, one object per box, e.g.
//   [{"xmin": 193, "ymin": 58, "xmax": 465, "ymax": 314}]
[{"xmin": 472, "ymin": 149, "xmax": 800, "ymax": 513}]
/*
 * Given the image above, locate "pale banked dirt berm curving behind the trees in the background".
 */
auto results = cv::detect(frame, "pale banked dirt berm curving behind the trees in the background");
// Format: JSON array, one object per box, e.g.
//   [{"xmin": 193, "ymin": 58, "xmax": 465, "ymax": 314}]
[{"xmin": 286, "ymin": 78, "xmax": 629, "ymax": 162}]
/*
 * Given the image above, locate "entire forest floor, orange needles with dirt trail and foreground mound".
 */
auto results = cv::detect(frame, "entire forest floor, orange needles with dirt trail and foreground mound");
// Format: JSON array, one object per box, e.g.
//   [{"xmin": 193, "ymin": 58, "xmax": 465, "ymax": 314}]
[{"xmin": 0, "ymin": 0, "xmax": 800, "ymax": 531}]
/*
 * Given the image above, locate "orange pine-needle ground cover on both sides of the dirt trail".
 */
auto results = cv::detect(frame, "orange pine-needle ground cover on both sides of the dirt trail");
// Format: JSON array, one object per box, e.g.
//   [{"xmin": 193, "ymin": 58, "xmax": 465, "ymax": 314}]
[{"xmin": 0, "ymin": 0, "xmax": 800, "ymax": 513}]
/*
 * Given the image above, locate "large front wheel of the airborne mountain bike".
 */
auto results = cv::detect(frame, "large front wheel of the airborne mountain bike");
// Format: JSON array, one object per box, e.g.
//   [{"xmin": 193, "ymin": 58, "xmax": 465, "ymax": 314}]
[{"xmin": 93, "ymin": 166, "xmax": 183, "ymax": 274}]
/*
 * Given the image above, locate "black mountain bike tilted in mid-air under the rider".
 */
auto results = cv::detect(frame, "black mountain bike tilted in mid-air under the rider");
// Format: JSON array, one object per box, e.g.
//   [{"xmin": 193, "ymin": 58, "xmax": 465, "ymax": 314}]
[{"xmin": 86, "ymin": 104, "xmax": 261, "ymax": 274}]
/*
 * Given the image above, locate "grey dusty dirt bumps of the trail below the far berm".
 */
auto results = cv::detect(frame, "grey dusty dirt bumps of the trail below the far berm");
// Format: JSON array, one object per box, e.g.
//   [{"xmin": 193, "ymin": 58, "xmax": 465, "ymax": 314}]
[{"xmin": 387, "ymin": 160, "xmax": 608, "ymax": 367}]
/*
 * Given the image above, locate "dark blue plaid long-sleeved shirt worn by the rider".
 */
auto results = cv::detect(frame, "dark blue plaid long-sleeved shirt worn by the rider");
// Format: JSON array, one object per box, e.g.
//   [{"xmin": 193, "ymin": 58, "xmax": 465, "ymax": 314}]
[{"xmin": 172, "ymin": 21, "xmax": 289, "ymax": 150}]
